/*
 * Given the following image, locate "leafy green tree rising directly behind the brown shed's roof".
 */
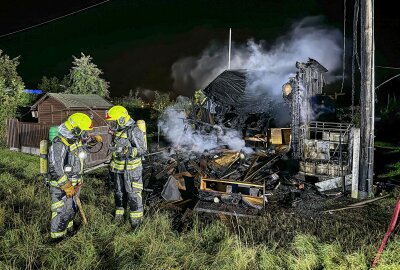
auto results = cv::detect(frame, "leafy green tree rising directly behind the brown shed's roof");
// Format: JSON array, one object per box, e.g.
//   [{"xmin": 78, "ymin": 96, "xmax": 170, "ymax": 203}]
[{"xmin": 66, "ymin": 53, "xmax": 109, "ymax": 97}]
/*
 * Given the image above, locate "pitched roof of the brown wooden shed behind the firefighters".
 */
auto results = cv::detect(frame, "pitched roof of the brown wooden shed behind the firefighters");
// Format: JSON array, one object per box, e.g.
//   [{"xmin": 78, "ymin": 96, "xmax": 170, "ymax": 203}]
[{"xmin": 31, "ymin": 93, "xmax": 113, "ymax": 109}]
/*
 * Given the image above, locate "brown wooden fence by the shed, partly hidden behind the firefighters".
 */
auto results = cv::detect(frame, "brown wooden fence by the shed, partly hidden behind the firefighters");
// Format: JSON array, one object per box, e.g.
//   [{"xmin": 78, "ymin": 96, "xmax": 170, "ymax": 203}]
[{"xmin": 7, "ymin": 119, "xmax": 111, "ymax": 167}]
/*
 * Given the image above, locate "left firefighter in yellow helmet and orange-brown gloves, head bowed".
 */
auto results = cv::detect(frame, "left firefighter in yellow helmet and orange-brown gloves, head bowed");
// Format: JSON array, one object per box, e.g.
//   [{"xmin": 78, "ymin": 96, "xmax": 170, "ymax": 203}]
[{"xmin": 48, "ymin": 113, "xmax": 93, "ymax": 239}]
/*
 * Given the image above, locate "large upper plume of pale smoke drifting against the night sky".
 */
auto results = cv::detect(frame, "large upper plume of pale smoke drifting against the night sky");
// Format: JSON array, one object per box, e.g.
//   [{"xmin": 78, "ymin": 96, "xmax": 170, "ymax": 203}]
[{"xmin": 172, "ymin": 17, "xmax": 343, "ymax": 96}]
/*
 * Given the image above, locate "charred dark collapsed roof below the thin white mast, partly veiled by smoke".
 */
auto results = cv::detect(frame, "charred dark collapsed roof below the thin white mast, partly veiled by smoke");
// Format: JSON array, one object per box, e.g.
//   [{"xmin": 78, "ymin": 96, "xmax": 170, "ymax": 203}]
[{"xmin": 203, "ymin": 69, "xmax": 290, "ymax": 132}]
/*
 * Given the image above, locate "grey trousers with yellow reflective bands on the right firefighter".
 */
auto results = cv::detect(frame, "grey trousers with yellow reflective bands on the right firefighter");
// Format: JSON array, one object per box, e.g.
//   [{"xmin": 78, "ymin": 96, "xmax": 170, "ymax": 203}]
[{"xmin": 111, "ymin": 167, "xmax": 143, "ymax": 224}]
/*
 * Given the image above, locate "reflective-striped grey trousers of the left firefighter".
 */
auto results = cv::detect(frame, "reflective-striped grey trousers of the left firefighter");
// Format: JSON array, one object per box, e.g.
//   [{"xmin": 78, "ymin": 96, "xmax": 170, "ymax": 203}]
[{"xmin": 50, "ymin": 187, "xmax": 80, "ymax": 238}]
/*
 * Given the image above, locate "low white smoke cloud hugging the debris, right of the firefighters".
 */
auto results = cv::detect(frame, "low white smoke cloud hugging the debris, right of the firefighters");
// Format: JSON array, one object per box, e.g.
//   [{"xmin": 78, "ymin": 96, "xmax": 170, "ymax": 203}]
[{"xmin": 158, "ymin": 107, "xmax": 252, "ymax": 153}]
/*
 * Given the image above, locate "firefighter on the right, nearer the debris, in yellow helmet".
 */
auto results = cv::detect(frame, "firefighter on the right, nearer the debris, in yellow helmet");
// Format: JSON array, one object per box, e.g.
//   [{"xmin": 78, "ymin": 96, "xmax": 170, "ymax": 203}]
[{"xmin": 106, "ymin": 106, "xmax": 146, "ymax": 228}]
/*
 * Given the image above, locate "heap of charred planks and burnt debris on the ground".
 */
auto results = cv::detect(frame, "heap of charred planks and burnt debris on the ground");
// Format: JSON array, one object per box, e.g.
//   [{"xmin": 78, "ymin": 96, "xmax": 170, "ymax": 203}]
[{"xmin": 144, "ymin": 131, "xmax": 304, "ymax": 216}]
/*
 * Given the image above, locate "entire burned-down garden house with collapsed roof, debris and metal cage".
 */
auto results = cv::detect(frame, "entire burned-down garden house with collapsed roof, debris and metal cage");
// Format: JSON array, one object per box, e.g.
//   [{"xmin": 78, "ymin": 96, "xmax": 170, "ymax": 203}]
[{"xmin": 152, "ymin": 59, "xmax": 358, "ymax": 215}]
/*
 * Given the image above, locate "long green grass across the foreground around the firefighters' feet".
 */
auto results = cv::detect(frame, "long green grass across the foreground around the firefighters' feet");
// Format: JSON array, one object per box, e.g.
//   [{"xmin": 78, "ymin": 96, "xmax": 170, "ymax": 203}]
[{"xmin": 0, "ymin": 149, "xmax": 400, "ymax": 270}]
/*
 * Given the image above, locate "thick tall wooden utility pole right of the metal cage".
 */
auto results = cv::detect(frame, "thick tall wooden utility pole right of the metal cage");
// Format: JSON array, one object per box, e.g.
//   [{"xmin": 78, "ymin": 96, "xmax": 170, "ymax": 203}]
[{"xmin": 359, "ymin": 0, "xmax": 375, "ymax": 199}]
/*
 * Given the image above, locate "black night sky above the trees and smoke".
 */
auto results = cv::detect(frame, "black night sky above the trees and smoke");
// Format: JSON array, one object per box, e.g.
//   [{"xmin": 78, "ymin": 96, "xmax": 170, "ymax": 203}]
[{"xmin": 0, "ymin": 0, "xmax": 400, "ymax": 104}]
